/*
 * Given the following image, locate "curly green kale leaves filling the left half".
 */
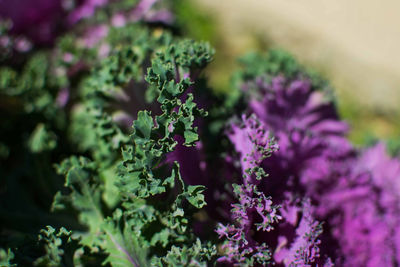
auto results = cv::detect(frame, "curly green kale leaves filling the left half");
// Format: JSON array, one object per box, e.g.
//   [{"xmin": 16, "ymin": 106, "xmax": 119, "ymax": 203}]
[{"xmin": 0, "ymin": 2, "xmax": 216, "ymax": 266}]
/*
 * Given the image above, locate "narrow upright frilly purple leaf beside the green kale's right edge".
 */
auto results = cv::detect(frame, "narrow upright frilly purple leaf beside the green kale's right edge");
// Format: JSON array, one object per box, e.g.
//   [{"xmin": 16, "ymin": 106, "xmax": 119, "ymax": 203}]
[{"xmin": 216, "ymin": 116, "xmax": 281, "ymax": 266}]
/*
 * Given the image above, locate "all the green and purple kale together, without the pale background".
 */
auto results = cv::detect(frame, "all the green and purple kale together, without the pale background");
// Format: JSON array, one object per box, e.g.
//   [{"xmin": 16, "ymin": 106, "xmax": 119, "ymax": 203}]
[{"xmin": 0, "ymin": 0, "xmax": 400, "ymax": 266}]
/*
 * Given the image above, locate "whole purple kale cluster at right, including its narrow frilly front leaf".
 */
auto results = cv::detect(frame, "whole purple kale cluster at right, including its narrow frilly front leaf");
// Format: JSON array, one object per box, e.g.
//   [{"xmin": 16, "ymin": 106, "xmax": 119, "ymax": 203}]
[{"xmin": 217, "ymin": 76, "xmax": 400, "ymax": 266}]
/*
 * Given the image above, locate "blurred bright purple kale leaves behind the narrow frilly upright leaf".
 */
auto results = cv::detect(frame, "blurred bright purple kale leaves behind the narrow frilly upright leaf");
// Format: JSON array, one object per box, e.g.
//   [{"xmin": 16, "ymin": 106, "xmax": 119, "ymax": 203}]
[{"xmin": 239, "ymin": 76, "xmax": 400, "ymax": 266}]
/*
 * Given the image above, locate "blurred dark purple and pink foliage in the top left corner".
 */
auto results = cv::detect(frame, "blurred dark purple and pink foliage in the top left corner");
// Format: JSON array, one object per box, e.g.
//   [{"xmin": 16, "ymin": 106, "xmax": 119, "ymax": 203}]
[{"xmin": 0, "ymin": 0, "xmax": 174, "ymax": 46}]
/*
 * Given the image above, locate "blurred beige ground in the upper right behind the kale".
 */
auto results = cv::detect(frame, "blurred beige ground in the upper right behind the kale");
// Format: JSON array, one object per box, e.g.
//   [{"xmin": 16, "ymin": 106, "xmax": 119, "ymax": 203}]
[{"xmin": 197, "ymin": 0, "xmax": 400, "ymax": 142}]
